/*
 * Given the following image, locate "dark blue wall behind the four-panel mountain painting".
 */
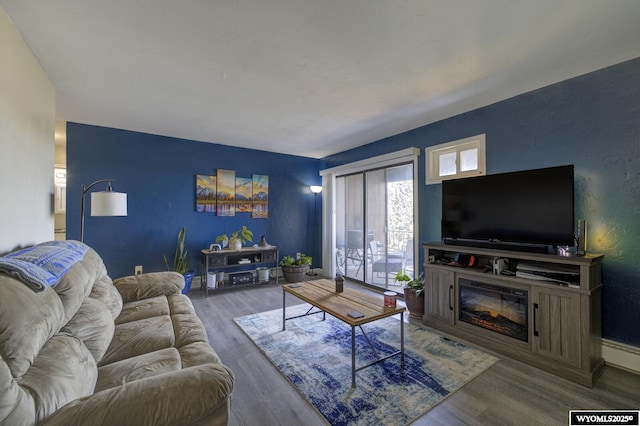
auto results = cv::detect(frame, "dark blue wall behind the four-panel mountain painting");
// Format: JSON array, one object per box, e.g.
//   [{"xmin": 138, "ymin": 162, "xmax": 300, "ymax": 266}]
[{"xmin": 67, "ymin": 123, "xmax": 321, "ymax": 278}]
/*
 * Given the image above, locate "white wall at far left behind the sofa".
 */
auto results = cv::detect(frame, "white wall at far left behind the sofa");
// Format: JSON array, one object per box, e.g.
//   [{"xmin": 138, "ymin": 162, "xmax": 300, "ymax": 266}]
[{"xmin": 0, "ymin": 7, "xmax": 55, "ymax": 253}]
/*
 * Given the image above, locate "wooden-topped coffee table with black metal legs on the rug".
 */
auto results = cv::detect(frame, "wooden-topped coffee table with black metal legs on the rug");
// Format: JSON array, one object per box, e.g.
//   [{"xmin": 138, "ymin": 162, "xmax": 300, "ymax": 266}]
[{"xmin": 282, "ymin": 279, "xmax": 405, "ymax": 387}]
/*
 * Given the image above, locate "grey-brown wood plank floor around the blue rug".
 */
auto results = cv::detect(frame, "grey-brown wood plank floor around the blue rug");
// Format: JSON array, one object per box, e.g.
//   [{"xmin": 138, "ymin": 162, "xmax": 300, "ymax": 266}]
[{"xmin": 189, "ymin": 284, "xmax": 640, "ymax": 426}]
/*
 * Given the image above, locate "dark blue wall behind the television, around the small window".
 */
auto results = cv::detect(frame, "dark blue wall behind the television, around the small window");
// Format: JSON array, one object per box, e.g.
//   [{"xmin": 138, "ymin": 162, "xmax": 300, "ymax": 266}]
[{"xmin": 325, "ymin": 59, "xmax": 640, "ymax": 346}]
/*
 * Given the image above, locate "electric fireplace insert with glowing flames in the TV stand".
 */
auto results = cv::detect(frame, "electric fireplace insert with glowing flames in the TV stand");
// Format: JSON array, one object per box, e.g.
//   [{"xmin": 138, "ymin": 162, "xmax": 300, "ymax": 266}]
[{"xmin": 458, "ymin": 278, "xmax": 529, "ymax": 342}]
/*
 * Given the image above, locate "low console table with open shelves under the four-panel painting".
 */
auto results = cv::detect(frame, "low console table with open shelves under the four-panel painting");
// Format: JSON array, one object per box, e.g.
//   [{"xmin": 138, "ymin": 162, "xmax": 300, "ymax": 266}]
[{"xmin": 200, "ymin": 246, "xmax": 278, "ymax": 297}]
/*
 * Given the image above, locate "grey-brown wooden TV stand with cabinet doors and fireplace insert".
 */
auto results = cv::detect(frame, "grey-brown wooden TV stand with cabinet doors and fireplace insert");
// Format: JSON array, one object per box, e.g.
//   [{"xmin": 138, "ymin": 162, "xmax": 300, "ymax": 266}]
[{"xmin": 423, "ymin": 242, "xmax": 604, "ymax": 386}]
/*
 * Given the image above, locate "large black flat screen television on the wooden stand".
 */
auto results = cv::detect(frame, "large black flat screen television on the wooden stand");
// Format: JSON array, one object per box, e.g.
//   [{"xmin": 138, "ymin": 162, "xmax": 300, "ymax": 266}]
[{"xmin": 442, "ymin": 165, "xmax": 574, "ymax": 252}]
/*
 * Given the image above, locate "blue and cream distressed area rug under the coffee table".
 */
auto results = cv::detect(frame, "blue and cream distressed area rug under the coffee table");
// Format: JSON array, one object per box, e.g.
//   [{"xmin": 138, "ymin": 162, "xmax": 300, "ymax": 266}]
[{"xmin": 234, "ymin": 304, "xmax": 498, "ymax": 425}]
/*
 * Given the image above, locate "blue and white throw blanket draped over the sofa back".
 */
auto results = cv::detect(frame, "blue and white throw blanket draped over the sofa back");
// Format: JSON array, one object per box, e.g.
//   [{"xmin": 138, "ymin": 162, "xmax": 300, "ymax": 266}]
[{"xmin": 0, "ymin": 240, "xmax": 89, "ymax": 291}]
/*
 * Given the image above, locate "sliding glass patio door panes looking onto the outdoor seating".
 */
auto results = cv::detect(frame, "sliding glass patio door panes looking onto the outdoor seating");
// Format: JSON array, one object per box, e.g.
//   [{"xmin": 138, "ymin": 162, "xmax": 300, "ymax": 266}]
[{"xmin": 336, "ymin": 163, "xmax": 414, "ymax": 290}]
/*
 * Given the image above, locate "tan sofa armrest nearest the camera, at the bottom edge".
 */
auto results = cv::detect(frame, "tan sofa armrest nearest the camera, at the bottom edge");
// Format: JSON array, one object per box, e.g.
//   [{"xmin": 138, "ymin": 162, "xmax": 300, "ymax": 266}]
[{"xmin": 42, "ymin": 364, "xmax": 234, "ymax": 426}]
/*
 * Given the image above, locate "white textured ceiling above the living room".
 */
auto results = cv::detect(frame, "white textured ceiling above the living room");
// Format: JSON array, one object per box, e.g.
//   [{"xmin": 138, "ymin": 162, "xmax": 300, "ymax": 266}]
[{"xmin": 0, "ymin": 0, "xmax": 640, "ymax": 158}]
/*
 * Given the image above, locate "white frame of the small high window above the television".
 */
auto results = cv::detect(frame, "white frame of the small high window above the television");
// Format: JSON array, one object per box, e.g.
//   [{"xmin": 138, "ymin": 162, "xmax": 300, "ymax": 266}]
[{"xmin": 424, "ymin": 133, "xmax": 487, "ymax": 185}]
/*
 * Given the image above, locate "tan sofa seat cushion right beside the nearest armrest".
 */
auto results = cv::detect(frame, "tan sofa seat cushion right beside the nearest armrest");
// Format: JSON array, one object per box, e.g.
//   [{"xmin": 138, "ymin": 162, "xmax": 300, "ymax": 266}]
[{"xmin": 95, "ymin": 348, "xmax": 182, "ymax": 392}]
